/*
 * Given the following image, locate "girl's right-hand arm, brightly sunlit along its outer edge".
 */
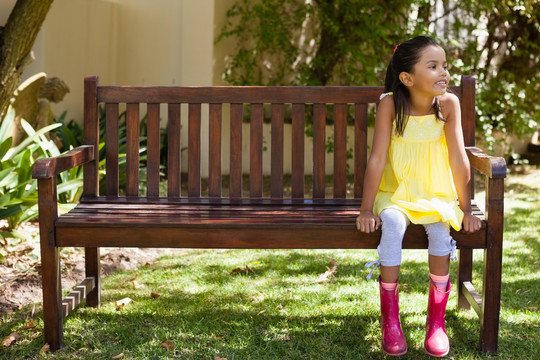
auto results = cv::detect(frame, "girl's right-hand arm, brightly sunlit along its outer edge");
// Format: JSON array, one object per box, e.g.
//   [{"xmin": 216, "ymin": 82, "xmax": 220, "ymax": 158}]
[{"xmin": 439, "ymin": 93, "xmax": 482, "ymax": 232}]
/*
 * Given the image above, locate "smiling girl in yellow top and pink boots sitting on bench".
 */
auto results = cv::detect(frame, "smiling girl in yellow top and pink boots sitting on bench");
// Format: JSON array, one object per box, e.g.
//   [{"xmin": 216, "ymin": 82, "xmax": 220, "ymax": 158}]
[{"xmin": 356, "ymin": 36, "xmax": 481, "ymax": 357}]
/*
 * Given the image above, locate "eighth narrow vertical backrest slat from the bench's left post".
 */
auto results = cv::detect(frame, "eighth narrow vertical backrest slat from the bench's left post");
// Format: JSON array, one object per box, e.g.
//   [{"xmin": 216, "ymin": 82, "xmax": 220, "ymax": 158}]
[{"xmin": 249, "ymin": 104, "xmax": 264, "ymax": 198}]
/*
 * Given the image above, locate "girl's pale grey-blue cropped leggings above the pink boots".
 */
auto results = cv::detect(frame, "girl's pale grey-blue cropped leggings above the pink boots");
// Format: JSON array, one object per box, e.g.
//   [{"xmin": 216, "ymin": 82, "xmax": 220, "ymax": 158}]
[{"xmin": 377, "ymin": 209, "xmax": 456, "ymax": 266}]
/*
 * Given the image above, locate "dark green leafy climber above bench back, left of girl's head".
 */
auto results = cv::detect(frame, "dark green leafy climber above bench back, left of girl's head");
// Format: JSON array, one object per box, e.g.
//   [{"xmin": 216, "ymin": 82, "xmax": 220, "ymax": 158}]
[{"xmin": 217, "ymin": 0, "xmax": 412, "ymax": 85}]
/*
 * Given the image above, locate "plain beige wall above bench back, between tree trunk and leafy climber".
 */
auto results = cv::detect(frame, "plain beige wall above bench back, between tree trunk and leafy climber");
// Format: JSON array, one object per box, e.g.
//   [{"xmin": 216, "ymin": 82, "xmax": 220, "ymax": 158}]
[{"xmin": 25, "ymin": 0, "xmax": 214, "ymax": 120}]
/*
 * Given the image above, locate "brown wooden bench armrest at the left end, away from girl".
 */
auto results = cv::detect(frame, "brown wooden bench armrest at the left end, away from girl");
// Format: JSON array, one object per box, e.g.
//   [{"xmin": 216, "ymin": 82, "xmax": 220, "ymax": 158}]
[{"xmin": 32, "ymin": 145, "xmax": 94, "ymax": 179}]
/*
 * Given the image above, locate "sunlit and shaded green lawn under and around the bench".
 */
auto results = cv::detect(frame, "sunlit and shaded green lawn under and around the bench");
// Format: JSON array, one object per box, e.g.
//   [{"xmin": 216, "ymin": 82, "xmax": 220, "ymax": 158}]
[{"xmin": 0, "ymin": 167, "xmax": 540, "ymax": 360}]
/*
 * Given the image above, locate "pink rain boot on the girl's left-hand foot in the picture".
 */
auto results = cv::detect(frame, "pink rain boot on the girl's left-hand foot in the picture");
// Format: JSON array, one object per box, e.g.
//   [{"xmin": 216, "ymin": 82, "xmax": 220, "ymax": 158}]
[{"xmin": 379, "ymin": 277, "xmax": 407, "ymax": 356}]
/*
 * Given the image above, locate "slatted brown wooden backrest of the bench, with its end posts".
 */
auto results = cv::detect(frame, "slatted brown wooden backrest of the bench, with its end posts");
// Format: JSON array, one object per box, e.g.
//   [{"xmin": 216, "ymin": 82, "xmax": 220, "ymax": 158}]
[{"xmin": 83, "ymin": 76, "xmax": 475, "ymax": 199}]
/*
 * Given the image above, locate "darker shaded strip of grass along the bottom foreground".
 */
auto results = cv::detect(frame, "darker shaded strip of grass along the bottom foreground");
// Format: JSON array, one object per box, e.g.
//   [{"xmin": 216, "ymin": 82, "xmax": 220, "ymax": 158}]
[{"xmin": 0, "ymin": 293, "xmax": 537, "ymax": 359}]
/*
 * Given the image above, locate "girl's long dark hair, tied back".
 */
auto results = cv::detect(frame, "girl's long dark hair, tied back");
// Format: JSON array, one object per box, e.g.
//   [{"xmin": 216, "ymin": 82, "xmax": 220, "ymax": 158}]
[{"xmin": 384, "ymin": 36, "xmax": 444, "ymax": 136}]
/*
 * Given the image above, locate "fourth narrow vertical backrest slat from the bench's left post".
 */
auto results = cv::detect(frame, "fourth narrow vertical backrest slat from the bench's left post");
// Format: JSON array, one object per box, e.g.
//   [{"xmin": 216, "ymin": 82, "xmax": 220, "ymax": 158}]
[{"xmin": 167, "ymin": 104, "xmax": 181, "ymax": 197}]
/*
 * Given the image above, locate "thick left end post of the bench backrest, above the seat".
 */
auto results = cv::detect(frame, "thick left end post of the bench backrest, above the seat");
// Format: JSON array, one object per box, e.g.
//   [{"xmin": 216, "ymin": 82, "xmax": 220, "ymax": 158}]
[{"xmin": 83, "ymin": 76, "xmax": 100, "ymax": 196}]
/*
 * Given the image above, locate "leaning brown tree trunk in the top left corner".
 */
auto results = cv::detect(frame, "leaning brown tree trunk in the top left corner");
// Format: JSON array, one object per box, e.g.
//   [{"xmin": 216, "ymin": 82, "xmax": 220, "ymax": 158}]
[{"xmin": 0, "ymin": 0, "xmax": 53, "ymax": 119}]
